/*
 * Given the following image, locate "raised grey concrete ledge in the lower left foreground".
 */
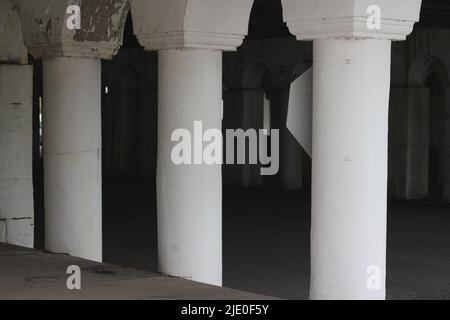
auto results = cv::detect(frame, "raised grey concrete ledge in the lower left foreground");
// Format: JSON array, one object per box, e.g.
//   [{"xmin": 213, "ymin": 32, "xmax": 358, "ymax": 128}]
[{"xmin": 0, "ymin": 244, "xmax": 271, "ymax": 300}]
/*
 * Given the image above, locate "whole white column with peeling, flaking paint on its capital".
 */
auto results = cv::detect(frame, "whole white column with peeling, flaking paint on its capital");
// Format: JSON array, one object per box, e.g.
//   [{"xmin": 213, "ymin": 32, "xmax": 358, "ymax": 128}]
[{"xmin": 15, "ymin": 0, "xmax": 129, "ymax": 262}]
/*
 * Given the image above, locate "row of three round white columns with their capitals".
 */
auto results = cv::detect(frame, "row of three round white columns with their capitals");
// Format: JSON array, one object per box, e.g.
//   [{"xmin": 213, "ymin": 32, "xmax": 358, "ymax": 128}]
[{"xmin": 0, "ymin": 0, "xmax": 421, "ymax": 299}]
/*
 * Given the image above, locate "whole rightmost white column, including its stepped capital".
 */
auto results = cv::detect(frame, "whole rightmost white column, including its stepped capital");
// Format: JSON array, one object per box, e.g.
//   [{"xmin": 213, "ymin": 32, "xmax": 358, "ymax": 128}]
[{"xmin": 283, "ymin": 0, "xmax": 421, "ymax": 299}]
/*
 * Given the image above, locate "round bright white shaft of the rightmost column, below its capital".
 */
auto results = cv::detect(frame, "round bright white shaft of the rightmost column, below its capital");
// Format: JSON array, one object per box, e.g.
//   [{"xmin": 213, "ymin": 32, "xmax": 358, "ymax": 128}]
[{"xmin": 310, "ymin": 39, "xmax": 391, "ymax": 299}]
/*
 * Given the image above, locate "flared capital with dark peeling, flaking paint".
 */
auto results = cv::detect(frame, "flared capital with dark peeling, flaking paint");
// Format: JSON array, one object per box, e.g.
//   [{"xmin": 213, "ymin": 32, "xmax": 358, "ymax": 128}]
[{"xmin": 16, "ymin": 0, "xmax": 129, "ymax": 59}]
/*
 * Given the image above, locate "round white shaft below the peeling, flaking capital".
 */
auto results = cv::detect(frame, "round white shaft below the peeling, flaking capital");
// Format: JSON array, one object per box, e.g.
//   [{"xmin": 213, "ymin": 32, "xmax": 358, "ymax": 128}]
[{"xmin": 43, "ymin": 57, "xmax": 102, "ymax": 261}]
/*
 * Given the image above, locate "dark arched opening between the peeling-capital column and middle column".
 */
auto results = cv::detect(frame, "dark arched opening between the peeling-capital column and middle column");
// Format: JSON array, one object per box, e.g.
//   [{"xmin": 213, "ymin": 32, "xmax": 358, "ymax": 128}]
[{"xmin": 102, "ymin": 12, "xmax": 158, "ymax": 272}]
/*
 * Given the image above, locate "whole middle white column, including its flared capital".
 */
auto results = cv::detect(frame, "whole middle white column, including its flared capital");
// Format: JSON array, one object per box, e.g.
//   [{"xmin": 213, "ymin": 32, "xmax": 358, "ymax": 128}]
[{"xmin": 130, "ymin": 0, "xmax": 253, "ymax": 286}]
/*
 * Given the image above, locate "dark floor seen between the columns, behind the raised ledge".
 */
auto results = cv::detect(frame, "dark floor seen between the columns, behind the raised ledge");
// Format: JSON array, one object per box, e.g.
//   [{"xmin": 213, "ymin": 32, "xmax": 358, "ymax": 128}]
[{"xmin": 104, "ymin": 180, "xmax": 450, "ymax": 299}]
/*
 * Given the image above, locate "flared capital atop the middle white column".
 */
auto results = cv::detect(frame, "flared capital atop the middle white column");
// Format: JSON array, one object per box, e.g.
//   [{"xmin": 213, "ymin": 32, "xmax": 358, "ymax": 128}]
[{"xmin": 130, "ymin": 0, "xmax": 253, "ymax": 51}]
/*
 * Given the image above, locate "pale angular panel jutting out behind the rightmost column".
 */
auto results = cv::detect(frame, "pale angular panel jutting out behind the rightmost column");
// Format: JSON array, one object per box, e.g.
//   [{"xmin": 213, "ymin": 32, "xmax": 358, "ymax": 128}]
[{"xmin": 286, "ymin": 67, "xmax": 313, "ymax": 156}]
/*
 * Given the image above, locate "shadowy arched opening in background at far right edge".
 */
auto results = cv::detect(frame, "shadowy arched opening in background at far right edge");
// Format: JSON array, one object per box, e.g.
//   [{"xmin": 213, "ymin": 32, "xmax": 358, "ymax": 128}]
[{"xmin": 408, "ymin": 56, "xmax": 450, "ymax": 201}]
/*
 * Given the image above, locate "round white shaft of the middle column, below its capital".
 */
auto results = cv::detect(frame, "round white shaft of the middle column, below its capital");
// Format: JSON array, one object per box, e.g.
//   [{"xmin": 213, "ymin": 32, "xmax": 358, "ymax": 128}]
[{"xmin": 157, "ymin": 49, "xmax": 222, "ymax": 285}]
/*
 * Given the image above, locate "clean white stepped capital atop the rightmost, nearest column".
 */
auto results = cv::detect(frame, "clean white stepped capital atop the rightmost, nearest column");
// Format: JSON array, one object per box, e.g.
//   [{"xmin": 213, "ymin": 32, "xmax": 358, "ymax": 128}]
[{"xmin": 282, "ymin": 0, "xmax": 422, "ymax": 40}]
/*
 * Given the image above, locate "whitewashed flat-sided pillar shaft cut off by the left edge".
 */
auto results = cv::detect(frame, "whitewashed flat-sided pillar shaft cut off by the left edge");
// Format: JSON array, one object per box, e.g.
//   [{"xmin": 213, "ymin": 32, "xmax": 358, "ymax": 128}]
[{"xmin": 0, "ymin": 64, "xmax": 34, "ymax": 248}]
